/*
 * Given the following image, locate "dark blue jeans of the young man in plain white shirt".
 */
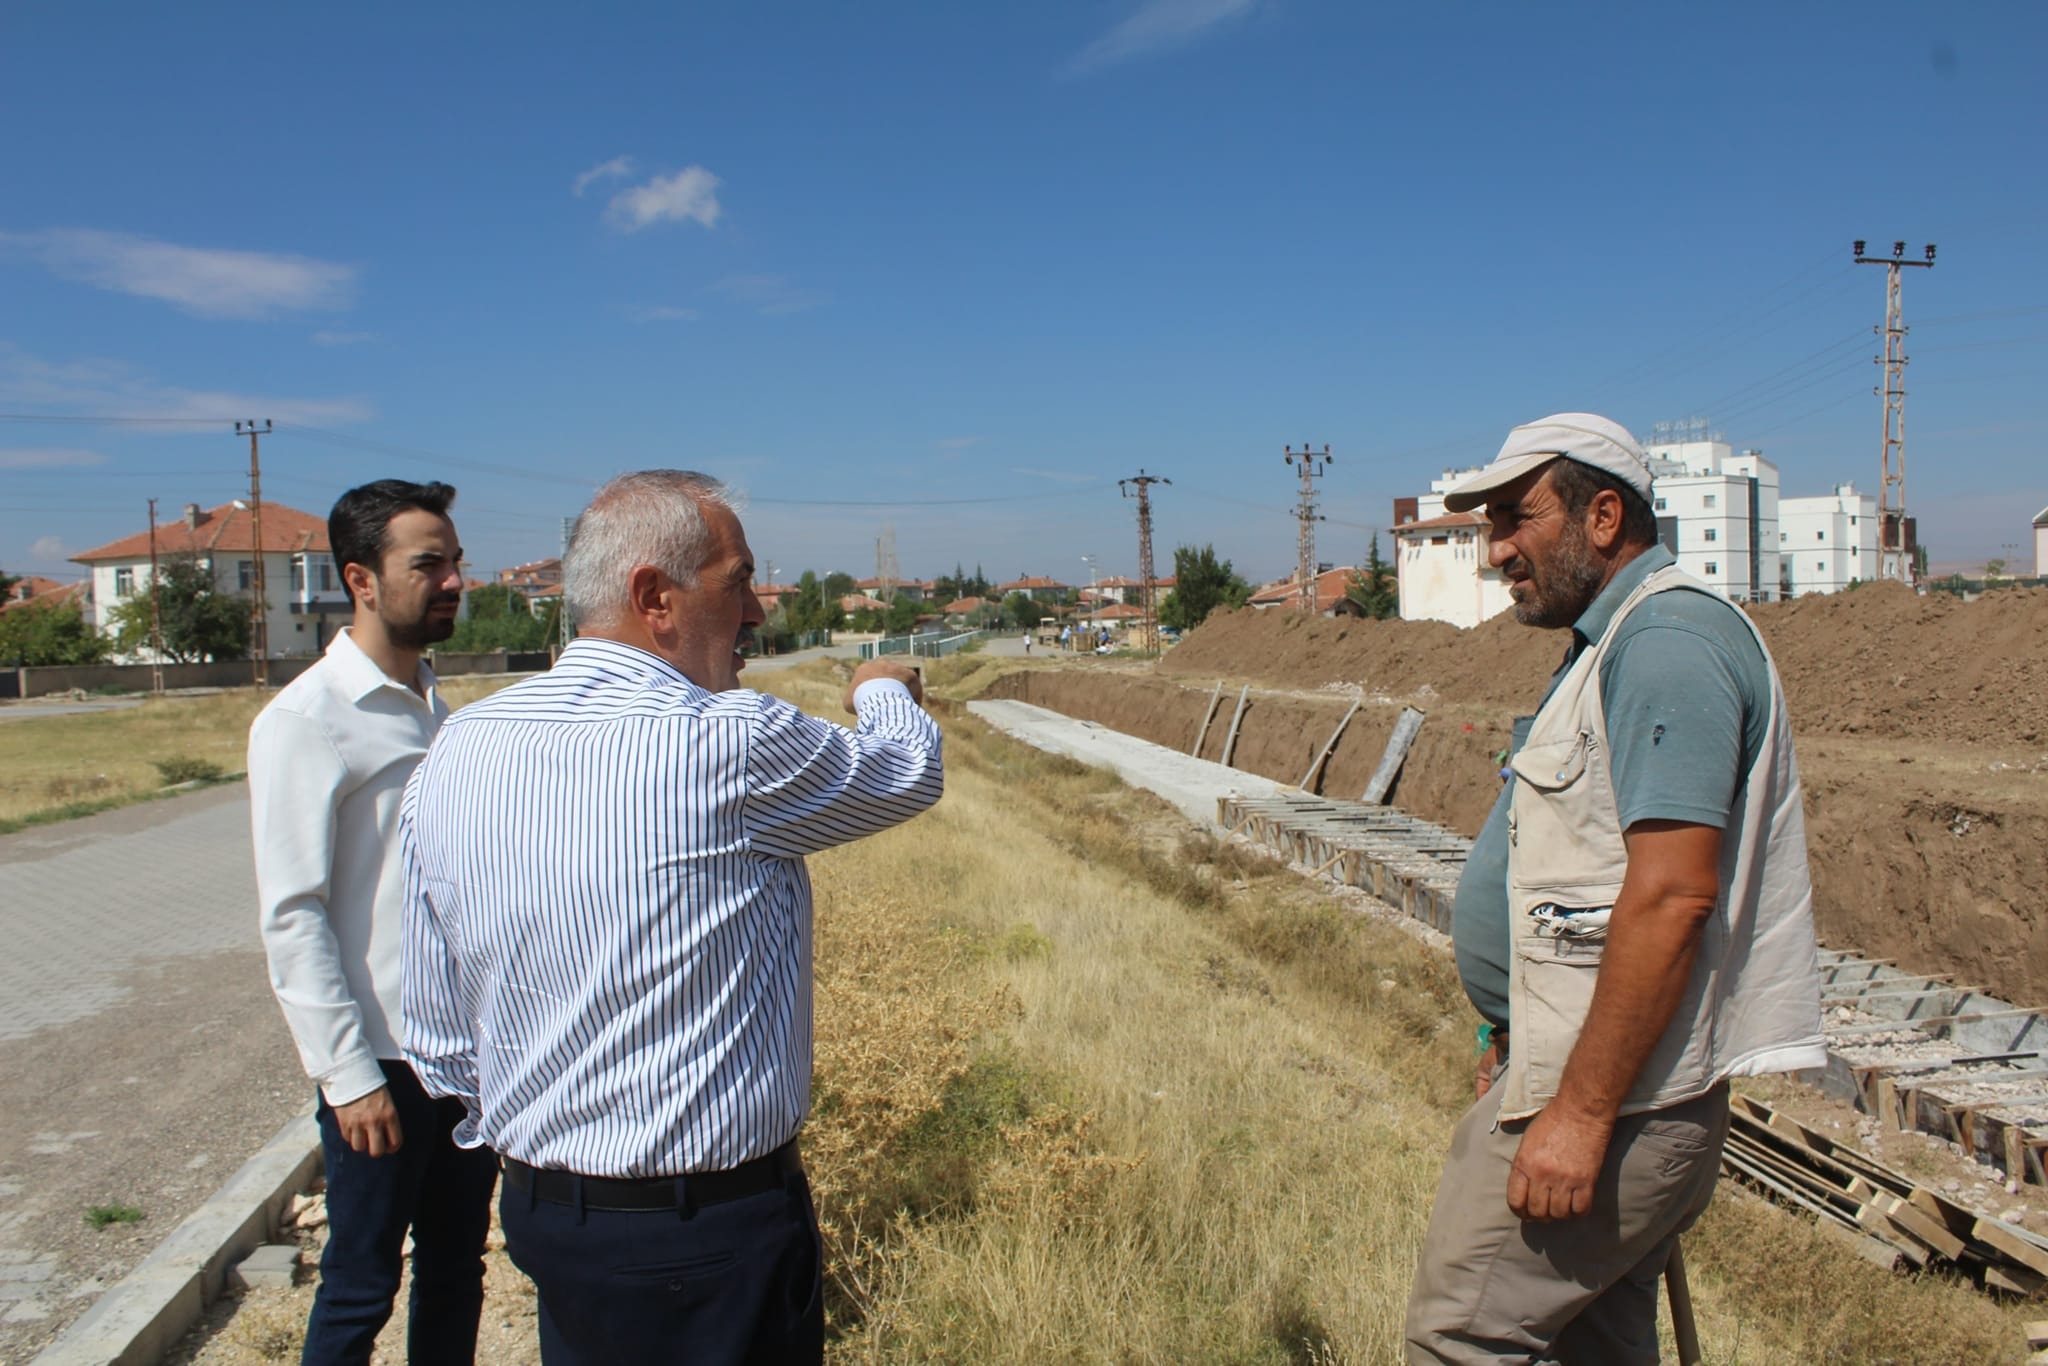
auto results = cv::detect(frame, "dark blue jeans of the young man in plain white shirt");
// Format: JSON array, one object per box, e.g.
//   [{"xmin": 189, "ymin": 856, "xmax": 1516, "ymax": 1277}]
[{"xmin": 299, "ymin": 1063, "xmax": 498, "ymax": 1366}]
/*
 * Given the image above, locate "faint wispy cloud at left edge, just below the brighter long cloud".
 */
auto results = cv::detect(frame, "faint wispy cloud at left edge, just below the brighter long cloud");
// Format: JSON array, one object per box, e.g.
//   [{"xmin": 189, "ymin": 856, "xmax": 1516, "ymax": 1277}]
[{"xmin": 0, "ymin": 342, "xmax": 375, "ymax": 426}]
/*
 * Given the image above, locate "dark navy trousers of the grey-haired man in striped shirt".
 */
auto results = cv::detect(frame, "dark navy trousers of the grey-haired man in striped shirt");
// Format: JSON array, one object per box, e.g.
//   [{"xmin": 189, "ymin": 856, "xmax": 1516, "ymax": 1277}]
[{"xmin": 498, "ymin": 1171, "xmax": 825, "ymax": 1366}]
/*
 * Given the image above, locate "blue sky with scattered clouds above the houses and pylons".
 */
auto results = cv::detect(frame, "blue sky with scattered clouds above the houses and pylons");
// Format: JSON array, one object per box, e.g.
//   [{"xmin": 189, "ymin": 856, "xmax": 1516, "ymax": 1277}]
[{"xmin": 0, "ymin": 0, "xmax": 2048, "ymax": 582}]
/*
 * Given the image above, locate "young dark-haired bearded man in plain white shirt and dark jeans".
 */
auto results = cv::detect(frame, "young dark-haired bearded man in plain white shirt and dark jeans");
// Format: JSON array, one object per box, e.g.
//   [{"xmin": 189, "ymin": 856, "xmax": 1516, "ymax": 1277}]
[{"xmin": 248, "ymin": 479, "xmax": 498, "ymax": 1366}]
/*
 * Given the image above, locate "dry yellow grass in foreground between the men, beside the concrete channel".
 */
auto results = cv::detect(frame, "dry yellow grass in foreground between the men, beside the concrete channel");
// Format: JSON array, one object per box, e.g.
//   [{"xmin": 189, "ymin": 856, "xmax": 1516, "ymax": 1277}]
[{"xmin": 155, "ymin": 659, "xmax": 2028, "ymax": 1364}]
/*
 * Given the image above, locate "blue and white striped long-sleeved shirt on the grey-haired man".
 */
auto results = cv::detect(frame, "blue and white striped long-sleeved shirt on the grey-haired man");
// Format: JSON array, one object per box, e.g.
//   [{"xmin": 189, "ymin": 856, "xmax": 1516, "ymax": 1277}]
[{"xmin": 399, "ymin": 637, "xmax": 944, "ymax": 1178}]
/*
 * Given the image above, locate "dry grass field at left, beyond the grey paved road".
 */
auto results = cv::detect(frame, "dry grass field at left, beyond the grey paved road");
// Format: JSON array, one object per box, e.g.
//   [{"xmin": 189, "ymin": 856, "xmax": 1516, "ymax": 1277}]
[{"xmin": 0, "ymin": 678, "xmax": 510, "ymax": 831}]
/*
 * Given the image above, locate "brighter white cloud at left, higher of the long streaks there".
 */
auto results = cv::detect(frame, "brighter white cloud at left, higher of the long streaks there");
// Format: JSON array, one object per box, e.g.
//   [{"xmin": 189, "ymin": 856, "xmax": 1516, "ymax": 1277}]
[{"xmin": 0, "ymin": 227, "xmax": 356, "ymax": 319}]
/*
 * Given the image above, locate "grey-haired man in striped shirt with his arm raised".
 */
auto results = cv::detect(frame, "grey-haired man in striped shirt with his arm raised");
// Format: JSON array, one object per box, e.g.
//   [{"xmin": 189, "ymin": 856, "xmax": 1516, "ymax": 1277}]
[{"xmin": 403, "ymin": 469, "xmax": 944, "ymax": 1366}]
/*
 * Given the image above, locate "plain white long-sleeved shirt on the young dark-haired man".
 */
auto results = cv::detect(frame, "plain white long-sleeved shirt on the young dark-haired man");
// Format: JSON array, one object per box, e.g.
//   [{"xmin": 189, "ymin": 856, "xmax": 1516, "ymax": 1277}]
[{"xmin": 250, "ymin": 629, "xmax": 449, "ymax": 1106}]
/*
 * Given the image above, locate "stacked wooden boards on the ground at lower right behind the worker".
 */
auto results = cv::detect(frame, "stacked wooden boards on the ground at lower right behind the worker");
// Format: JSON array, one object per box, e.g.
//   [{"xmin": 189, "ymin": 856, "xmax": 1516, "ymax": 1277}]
[{"xmin": 1720, "ymin": 1096, "xmax": 2048, "ymax": 1294}]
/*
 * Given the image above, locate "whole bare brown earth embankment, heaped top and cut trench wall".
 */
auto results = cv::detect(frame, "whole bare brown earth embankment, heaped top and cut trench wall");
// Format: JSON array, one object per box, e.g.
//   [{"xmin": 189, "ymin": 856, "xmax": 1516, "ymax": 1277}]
[{"xmin": 989, "ymin": 586, "xmax": 2048, "ymax": 1006}]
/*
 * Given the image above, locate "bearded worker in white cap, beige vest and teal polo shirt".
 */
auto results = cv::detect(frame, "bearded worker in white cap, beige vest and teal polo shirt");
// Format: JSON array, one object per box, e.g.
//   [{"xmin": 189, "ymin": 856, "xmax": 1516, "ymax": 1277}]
[{"xmin": 1407, "ymin": 414, "xmax": 1827, "ymax": 1366}]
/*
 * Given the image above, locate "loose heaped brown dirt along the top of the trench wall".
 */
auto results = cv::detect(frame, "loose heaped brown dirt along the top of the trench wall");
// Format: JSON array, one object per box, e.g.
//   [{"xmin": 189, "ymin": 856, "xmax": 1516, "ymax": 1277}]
[{"xmin": 1159, "ymin": 584, "xmax": 2048, "ymax": 748}]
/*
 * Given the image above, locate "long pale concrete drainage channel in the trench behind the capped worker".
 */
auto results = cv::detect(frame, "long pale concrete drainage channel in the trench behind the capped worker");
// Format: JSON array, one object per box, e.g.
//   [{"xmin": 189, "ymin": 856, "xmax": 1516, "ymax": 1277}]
[{"xmin": 969, "ymin": 702, "xmax": 2048, "ymax": 1188}]
